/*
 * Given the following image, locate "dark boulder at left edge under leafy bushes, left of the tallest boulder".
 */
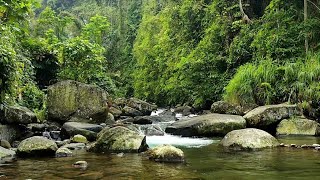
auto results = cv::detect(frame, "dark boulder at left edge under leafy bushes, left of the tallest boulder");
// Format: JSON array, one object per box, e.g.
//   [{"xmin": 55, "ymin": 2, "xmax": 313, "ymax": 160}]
[{"xmin": 2, "ymin": 105, "xmax": 37, "ymax": 124}]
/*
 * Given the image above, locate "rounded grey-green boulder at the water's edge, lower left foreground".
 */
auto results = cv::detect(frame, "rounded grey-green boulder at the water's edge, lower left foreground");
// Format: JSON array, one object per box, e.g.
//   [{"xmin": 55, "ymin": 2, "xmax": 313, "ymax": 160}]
[{"xmin": 17, "ymin": 136, "xmax": 58, "ymax": 156}]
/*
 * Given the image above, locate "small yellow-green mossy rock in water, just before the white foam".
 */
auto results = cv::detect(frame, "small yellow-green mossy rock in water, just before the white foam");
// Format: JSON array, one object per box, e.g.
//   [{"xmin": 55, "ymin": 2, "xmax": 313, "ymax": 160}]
[{"xmin": 147, "ymin": 145, "xmax": 184, "ymax": 162}]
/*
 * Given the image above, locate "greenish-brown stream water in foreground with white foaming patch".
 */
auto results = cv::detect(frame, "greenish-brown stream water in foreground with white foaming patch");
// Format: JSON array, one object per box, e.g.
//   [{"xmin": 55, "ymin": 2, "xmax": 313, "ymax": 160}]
[{"xmin": 0, "ymin": 136, "xmax": 320, "ymax": 180}]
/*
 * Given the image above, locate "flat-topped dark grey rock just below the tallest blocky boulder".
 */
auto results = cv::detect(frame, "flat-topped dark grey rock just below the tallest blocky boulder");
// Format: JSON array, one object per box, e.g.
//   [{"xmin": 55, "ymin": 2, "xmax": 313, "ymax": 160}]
[{"xmin": 61, "ymin": 122, "xmax": 103, "ymax": 141}]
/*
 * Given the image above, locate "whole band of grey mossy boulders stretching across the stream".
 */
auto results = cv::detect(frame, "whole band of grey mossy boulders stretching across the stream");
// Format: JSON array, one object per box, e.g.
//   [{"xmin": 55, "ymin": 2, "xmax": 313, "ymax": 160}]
[{"xmin": 0, "ymin": 81, "xmax": 319, "ymax": 165}]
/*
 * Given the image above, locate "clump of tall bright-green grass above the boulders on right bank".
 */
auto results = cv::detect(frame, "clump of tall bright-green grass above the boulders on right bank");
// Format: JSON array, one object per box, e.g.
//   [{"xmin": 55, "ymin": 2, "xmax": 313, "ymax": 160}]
[{"xmin": 224, "ymin": 54, "xmax": 320, "ymax": 105}]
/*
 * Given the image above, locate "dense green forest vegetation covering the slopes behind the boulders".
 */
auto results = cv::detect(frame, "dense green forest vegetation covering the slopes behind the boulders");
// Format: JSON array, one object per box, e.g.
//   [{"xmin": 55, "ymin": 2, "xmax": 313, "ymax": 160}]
[{"xmin": 0, "ymin": 0, "xmax": 320, "ymax": 114}]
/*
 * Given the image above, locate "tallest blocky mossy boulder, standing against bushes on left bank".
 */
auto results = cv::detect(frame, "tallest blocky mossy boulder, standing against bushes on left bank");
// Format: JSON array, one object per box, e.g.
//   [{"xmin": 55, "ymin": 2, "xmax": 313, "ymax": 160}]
[{"xmin": 47, "ymin": 81, "xmax": 108, "ymax": 123}]
